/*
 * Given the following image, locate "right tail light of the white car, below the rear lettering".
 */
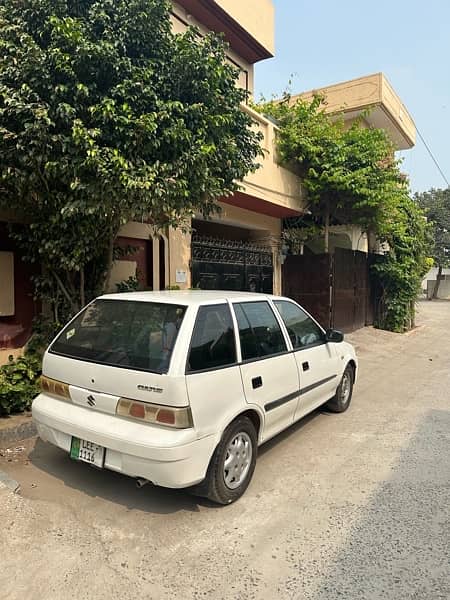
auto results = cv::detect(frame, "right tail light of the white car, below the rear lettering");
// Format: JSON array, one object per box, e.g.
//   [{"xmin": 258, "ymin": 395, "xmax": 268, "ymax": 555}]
[{"xmin": 116, "ymin": 398, "xmax": 192, "ymax": 429}]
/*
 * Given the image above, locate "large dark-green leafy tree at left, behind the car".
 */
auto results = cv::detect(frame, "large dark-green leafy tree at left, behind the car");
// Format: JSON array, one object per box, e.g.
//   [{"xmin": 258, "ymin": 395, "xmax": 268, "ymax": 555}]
[{"xmin": 0, "ymin": 0, "xmax": 259, "ymax": 324}]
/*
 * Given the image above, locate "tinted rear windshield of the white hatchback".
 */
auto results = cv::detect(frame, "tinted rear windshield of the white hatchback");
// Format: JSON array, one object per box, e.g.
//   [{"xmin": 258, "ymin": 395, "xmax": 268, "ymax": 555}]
[{"xmin": 50, "ymin": 300, "xmax": 186, "ymax": 373}]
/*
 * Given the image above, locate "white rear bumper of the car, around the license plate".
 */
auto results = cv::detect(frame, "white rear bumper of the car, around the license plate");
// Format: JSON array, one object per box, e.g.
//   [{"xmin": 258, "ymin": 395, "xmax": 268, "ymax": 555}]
[{"xmin": 32, "ymin": 394, "xmax": 216, "ymax": 488}]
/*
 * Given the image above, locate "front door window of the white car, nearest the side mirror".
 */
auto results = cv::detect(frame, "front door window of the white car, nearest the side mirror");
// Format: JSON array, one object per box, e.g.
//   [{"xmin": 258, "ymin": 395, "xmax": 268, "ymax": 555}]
[{"xmin": 274, "ymin": 300, "xmax": 325, "ymax": 350}]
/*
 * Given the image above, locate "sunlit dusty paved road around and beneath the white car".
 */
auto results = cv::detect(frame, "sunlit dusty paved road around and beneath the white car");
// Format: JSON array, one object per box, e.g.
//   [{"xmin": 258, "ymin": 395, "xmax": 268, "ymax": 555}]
[{"xmin": 0, "ymin": 302, "xmax": 450, "ymax": 600}]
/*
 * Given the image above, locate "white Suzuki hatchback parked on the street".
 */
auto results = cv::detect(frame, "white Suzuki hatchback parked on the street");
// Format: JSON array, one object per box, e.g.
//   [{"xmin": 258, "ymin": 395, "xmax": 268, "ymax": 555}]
[{"xmin": 32, "ymin": 290, "xmax": 357, "ymax": 504}]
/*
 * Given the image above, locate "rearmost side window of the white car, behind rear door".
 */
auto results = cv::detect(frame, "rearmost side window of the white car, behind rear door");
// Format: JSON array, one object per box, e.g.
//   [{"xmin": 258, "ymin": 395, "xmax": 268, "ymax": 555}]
[{"xmin": 187, "ymin": 304, "xmax": 236, "ymax": 373}]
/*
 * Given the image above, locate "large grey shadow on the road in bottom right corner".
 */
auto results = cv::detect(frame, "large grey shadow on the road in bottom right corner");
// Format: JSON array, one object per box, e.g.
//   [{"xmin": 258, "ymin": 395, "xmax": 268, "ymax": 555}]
[{"xmin": 296, "ymin": 410, "xmax": 450, "ymax": 600}]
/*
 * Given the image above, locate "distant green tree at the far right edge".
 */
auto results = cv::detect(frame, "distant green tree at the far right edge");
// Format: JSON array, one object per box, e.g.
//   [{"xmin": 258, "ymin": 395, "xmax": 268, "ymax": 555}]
[{"xmin": 414, "ymin": 188, "xmax": 450, "ymax": 300}]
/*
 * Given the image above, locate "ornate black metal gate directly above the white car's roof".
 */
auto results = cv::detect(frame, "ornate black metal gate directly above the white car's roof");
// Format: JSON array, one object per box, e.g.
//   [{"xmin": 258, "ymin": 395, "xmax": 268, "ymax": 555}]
[{"xmin": 192, "ymin": 237, "xmax": 273, "ymax": 294}]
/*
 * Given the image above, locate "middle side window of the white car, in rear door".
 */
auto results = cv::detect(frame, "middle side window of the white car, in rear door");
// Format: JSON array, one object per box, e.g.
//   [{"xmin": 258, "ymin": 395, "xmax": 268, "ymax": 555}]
[{"xmin": 233, "ymin": 302, "xmax": 287, "ymax": 360}]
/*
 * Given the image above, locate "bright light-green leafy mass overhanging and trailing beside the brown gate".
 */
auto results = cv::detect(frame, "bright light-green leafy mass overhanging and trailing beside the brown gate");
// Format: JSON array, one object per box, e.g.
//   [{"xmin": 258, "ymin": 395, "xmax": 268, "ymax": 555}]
[{"xmin": 258, "ymin": 95, "xmax": 430, "ymax": 332}]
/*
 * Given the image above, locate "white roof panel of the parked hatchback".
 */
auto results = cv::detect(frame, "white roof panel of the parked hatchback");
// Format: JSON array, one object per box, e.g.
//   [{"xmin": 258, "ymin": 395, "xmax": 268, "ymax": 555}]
[{"xmin": 100, "ymin": 290, "xmax": 279, "ymax": 306}]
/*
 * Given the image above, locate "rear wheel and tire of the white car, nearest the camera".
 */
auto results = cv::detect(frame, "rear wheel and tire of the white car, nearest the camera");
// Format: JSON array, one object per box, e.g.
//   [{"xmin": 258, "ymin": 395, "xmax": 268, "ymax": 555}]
[{"xmin": 192, "ymin": 417, "xmax": 258, "ymax": 504}]
